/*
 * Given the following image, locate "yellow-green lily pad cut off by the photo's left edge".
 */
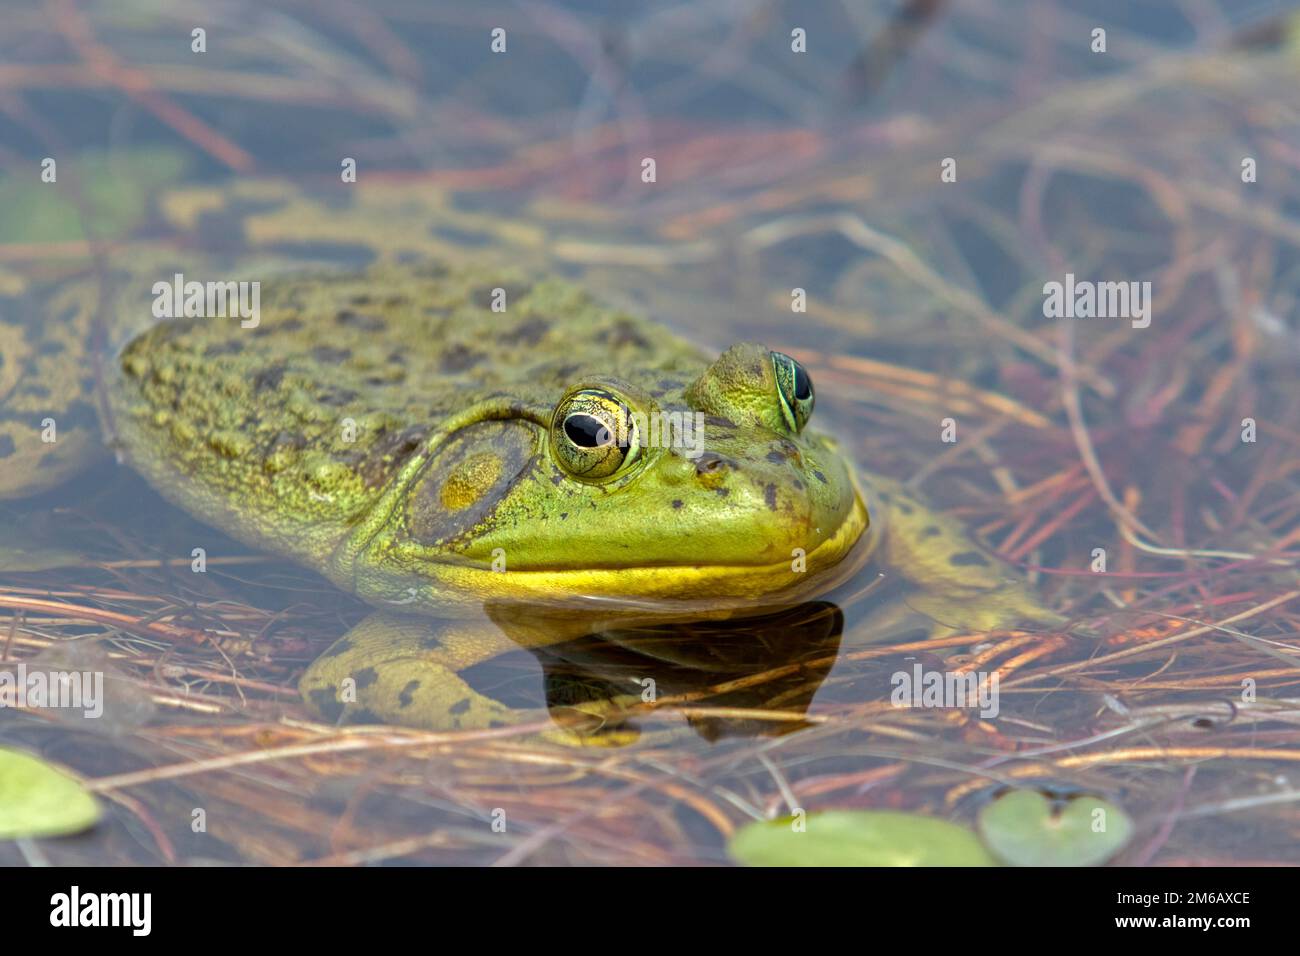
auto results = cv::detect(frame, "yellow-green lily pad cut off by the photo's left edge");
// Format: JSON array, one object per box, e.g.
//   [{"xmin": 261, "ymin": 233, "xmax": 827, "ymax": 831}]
[{"xmin": 0, "ymin": 748, "xmax": 99, "ymax": 840}]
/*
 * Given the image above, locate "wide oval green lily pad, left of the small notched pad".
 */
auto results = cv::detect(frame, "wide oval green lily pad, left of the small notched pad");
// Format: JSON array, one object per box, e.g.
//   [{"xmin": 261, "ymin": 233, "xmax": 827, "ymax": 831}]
[{"xmin": 727, "ymin": 810, "xmax": 996, "ymax": 866}]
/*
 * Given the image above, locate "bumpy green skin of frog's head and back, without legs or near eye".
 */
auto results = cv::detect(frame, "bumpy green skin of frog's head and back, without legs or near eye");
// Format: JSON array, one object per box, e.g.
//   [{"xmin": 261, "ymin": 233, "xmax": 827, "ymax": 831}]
[{"xmin": 111, "ymin": 267, "xmax": 866, "ymax": 615}]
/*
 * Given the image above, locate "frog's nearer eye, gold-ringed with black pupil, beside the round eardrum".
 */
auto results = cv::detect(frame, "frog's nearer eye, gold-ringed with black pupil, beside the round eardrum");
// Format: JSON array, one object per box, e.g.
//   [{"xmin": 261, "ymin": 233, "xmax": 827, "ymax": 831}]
[{"xmin": 551, "ymin": 389, "xmax": 641, "ymax": 481}]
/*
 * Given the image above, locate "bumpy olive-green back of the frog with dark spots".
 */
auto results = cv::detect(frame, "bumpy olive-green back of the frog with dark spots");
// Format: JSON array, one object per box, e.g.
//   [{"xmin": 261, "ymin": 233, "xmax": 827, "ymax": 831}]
[{"xmin": 109, "ymin": 257, "xmax": 705, "ymax": 563}]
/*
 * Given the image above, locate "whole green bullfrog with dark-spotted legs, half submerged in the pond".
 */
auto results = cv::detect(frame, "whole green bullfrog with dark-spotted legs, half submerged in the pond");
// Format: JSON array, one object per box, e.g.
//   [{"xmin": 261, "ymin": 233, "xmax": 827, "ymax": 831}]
[{"xmin": 0, "ymin": 184, "xmax": 1060, "ymax": 730}]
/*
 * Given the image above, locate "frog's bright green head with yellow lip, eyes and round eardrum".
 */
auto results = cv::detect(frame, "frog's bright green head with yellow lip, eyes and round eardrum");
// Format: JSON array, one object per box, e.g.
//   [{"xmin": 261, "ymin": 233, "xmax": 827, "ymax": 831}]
[{"xmin": 358, "ymin": 343, "xmax": 867, "ymax": 613}]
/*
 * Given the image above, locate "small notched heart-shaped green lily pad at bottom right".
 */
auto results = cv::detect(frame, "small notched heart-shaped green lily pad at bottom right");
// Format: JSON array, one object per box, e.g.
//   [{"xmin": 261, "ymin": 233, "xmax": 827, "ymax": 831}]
[{"xmin": 976, "ymin": 790, "xmax": 1134, "ymax": 866}]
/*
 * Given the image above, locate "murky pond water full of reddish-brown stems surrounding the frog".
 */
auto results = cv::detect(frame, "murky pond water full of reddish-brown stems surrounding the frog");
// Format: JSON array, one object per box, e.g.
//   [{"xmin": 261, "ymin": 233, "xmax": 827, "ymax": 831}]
[{"xmin": 0, "ymin": 0, "xmax": 1300, "ymax": 866}]
